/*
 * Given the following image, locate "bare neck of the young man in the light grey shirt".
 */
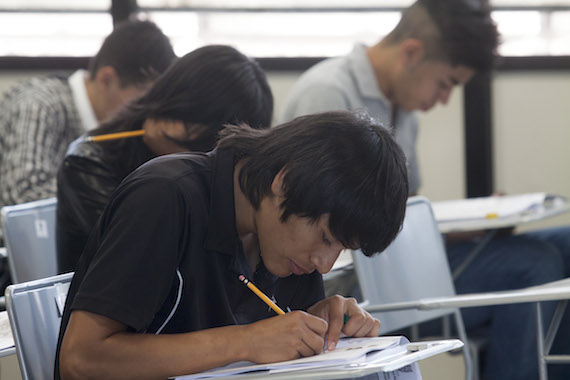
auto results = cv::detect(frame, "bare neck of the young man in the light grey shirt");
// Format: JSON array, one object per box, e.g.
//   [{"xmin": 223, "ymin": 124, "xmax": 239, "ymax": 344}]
[{"xmin": 366, "ymin": 41, "xmax": 397, "ymax": 106}]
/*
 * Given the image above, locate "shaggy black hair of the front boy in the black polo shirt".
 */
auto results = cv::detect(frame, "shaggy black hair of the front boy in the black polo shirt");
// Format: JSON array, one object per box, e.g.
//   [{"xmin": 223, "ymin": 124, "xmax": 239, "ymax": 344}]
[{"xmin": 218, "ymin": 111, "xmax": 408, "ymax": 256}]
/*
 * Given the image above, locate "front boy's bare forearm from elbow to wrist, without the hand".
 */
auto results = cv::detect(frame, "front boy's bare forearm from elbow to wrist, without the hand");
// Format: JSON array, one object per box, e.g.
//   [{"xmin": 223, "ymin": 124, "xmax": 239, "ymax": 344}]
[{"xmin": 60, "ymin": 314, "xmax": 246, "ymax": 380}]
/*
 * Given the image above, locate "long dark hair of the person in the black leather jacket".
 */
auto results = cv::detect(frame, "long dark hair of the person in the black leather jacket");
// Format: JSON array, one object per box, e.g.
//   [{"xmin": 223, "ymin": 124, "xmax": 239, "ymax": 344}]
[{"xmin": 89, "ymin": 45, "xmax": 273, "ymax": 175}]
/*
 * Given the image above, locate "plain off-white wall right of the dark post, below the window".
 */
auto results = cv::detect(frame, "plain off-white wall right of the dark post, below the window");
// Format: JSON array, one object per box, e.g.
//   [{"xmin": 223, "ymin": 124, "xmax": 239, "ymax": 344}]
[{"xmin": 493, "ymin": 71, "xmax": 570, "ymax": 229}]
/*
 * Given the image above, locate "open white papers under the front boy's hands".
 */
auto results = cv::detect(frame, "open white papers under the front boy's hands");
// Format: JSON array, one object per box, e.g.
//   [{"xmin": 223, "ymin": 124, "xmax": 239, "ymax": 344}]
[{"xmin": 176, "ymin": 336, "xmax": 463, "ymax": 380}]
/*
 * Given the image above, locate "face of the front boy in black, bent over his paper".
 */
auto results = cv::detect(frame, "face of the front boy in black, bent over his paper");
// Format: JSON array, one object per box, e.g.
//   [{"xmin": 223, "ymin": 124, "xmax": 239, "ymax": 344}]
[{"xmin": 256, "ymin": 174, "xmax": 345, "ymax": 277}]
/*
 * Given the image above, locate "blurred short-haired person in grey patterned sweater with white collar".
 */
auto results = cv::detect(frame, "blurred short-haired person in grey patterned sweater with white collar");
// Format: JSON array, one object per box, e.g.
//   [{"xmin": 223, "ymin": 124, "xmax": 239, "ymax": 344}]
[{"xmin": 0, "ymin": 21, "xmax": 176, "ymax": 235}]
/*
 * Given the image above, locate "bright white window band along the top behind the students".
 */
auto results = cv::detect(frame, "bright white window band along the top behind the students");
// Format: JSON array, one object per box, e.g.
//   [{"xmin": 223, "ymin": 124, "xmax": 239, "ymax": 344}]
[{"xmin": 0, "ymin": 0, "xmax": 570, "ymax": 57}]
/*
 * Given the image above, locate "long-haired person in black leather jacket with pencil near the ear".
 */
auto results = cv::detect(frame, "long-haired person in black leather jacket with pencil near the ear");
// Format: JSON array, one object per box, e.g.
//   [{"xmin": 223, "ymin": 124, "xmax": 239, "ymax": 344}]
[{"xmin": 57, "ymin": 45, "xmax": 273, "ymax": 273}]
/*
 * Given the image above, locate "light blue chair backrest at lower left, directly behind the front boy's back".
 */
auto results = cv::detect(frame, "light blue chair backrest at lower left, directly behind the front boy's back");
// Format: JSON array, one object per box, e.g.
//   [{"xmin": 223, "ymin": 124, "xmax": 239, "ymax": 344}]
[{"xmin": 6, "ymin": 272, "xmax": 73, "ymax": 380}]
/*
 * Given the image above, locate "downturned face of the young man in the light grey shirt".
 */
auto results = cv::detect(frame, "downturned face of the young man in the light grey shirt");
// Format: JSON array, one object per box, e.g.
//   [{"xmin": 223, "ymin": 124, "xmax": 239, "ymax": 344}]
[{"xmin": 395, "ymin": 60, "xmax": 475, "ymax": 111}]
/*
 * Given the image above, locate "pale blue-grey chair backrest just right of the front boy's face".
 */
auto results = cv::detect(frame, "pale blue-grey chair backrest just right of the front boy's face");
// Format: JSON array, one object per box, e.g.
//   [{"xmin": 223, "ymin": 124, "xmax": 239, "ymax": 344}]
[{"xmin": 353, "ymin": 196, "xmax": 455, "ymax": 334}]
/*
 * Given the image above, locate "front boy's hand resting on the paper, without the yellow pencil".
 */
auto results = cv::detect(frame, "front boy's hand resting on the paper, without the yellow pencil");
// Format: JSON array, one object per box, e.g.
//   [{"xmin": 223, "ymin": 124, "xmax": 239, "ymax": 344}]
[{"xmin": 307, "ymin": 295, "xmax": 380, "ymax": 350}]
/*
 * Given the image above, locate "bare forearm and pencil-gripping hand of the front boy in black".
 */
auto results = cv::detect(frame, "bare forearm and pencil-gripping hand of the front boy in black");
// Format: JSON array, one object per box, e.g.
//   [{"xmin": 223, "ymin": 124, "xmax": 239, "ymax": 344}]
[{"xmin": 59, "ymin": 310, "xmax": 327, "ymax": 380}]
